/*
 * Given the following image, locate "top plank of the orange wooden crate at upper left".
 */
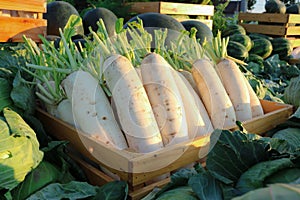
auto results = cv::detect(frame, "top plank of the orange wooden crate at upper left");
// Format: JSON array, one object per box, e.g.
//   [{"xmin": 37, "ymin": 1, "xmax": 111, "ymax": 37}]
[{"xmin": 0, "ymin": 0, "xmax": 46, "ymax": 13}]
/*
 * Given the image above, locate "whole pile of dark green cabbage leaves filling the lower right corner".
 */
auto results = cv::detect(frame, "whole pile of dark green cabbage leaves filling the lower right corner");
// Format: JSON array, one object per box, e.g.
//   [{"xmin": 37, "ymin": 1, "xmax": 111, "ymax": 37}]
[{"xmin": 144, "ymin": 110, "xmax": 300, "ymax": 200}]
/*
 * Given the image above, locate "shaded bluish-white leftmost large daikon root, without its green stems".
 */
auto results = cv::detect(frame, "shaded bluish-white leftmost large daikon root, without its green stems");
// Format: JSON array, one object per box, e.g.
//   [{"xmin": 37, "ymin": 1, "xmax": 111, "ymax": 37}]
[{"xmin": 62, "ymin": 71, "xmax": 127, "ymax": 149}]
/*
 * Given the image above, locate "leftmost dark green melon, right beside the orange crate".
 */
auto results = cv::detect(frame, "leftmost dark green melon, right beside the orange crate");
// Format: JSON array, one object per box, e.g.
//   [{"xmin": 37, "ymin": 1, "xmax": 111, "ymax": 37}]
[{"xmin": 43, "ymin": 1, "xmax": 84, "ymax": 36}]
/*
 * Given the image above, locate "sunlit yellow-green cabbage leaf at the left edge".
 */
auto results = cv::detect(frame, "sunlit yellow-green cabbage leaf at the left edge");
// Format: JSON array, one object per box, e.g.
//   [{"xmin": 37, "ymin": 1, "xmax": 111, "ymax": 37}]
[{"xmin": 0, "ymin": 108, "xmax": 43, "ymax": 190}]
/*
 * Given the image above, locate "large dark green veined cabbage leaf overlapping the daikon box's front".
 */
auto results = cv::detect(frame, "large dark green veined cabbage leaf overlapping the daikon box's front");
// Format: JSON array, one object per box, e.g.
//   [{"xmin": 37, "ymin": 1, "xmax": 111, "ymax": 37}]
[{"xmin": 206, "ymin": 130, "xmax": 268, "ymax": 184}]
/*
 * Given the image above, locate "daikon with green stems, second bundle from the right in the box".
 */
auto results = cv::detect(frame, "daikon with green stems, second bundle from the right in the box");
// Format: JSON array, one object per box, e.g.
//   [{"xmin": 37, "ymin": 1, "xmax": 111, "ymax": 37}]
[{"xmin": 159, "ymin": 29, "xmax": 236, "ymax": 130}]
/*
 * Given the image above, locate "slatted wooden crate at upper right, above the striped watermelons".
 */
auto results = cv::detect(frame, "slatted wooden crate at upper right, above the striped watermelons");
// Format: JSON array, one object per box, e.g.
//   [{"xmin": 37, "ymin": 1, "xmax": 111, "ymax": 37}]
[{"xmin": 238, "ymin": 13, "xmax": 300, "ymax": 47}]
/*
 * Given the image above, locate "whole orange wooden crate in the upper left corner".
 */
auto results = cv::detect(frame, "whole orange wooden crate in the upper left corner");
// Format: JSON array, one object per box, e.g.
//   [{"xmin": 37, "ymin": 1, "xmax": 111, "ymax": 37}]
[{"xmin": 0, "ymin": 0, "xmax": 47, "ymax": 42}]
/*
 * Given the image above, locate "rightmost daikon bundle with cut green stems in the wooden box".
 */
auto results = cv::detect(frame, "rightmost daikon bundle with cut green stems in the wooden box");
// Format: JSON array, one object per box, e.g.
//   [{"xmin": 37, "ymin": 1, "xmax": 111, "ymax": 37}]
[{"xmin": 206, "ymin": 33, "xmax": 263, "ymax": 122}]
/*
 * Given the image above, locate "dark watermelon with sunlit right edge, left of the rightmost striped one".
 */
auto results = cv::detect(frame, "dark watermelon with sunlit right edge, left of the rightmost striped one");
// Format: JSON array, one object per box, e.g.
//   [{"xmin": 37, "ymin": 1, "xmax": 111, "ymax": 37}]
[{"xmin": 249, "ymin": 38, "xmax": 273, "ymax": 59}]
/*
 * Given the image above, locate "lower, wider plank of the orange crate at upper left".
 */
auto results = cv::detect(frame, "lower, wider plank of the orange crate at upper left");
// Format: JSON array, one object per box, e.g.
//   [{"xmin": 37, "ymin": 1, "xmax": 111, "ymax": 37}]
[{"xmin": 0, "ymin": 16, "xmax": 47, "ymax": 42}]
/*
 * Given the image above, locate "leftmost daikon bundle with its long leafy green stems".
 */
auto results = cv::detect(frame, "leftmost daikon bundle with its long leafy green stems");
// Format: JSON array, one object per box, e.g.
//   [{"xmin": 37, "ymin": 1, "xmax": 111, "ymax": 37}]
[{"xmin": 24, "ymin": 18, "xmax": 128, "ymax": 149}]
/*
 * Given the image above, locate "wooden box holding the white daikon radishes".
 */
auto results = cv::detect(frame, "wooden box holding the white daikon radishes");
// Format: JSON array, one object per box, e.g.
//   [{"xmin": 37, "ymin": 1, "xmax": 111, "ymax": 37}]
[{"xmin": 37, "ymin": 100, "xmax": 293, "ymax": 199}]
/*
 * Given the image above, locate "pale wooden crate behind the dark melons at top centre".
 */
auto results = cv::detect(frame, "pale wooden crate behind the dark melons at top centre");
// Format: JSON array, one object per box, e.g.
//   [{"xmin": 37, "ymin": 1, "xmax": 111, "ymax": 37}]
[{"xmin": 130, "ymin": 1, "xmax": 214, "ymax": 29}]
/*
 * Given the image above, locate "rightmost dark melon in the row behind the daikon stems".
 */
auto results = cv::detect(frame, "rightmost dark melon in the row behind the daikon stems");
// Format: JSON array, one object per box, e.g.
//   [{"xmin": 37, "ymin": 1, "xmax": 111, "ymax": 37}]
[{"xmin": 181, "ymin": 20, "xmax": 213, "ymax": 44}]
